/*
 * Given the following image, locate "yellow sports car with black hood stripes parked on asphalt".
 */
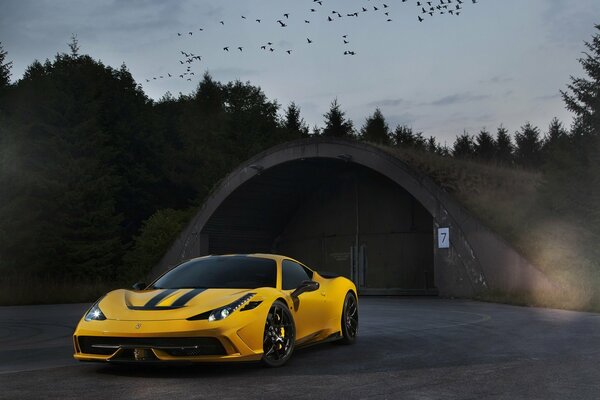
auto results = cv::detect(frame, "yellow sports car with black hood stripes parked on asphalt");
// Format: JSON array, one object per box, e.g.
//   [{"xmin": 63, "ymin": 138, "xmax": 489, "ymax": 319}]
[{"xmin": 73, "ymin": 254, "xmax": 358, "ymax": 367}]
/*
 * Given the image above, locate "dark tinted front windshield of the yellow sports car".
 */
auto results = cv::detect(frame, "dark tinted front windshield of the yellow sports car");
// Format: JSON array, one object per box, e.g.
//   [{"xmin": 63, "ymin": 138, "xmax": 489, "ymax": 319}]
[{"xmin": 152, "ymin": 256, "xmax": 277, "ymax": 289}]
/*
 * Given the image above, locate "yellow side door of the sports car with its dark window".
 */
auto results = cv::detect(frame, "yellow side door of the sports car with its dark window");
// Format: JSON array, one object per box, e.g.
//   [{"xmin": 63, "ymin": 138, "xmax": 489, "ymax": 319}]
[{"xmin": 281, "ymin": 260, "xmax": 327, "ymax": 342}]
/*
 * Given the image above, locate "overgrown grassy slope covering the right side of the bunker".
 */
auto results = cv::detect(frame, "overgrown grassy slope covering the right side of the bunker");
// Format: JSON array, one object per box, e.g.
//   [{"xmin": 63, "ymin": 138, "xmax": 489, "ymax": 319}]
[{"xmin": 384, "ymin": 148, "xmax": 600, "ymax": 311}]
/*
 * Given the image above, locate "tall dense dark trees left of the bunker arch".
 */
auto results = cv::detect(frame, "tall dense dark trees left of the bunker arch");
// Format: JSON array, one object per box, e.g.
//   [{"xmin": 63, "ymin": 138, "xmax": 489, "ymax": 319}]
[{"xmin": 0, "ymin": 42, "xmax": 310, "ymax": 280}]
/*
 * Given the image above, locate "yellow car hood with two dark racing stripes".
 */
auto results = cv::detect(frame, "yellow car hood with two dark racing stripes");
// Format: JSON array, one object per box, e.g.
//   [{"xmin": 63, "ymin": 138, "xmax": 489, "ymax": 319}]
[{"xmin": 99, "ymin": 289, "xmax": 257, "ymax": 321}]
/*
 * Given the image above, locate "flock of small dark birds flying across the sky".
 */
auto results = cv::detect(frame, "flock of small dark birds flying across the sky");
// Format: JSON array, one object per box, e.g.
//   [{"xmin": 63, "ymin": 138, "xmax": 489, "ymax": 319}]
[{"xmin": 146, "ymin": 0, "xmax": 479, "ymax": 82}]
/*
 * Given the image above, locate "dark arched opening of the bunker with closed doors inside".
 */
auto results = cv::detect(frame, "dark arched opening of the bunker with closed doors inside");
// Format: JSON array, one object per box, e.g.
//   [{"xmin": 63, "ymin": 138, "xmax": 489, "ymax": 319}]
[{"xmin": 200, "ymin": 158, "xmax": 436, "ymax": 294}]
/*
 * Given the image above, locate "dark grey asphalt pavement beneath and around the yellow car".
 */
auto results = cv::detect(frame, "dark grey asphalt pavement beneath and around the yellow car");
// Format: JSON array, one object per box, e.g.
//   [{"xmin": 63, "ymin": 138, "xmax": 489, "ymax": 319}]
[{"xmin": 0, "ymin": 297, "xmax": 600, "ymax": 400}]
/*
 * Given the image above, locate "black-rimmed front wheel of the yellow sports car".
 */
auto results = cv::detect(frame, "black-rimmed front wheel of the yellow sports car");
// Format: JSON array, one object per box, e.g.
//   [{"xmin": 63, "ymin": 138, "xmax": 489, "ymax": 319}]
[{"xmin": 262, "ymin": 300, "xmax": 296, "ymax": 367}]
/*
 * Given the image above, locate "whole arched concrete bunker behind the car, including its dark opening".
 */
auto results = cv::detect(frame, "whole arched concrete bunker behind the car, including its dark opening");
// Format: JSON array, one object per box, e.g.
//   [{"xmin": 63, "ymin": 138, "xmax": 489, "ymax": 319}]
[{"xmin": 153, "ymin": 138, "xmax": 552, "ymax": 297}]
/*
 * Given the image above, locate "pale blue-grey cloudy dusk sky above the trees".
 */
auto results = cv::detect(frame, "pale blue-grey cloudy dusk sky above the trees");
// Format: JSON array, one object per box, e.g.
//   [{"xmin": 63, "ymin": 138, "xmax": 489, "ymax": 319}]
[{"xmin": 0, "ymin": 0, "xmax": 600, "ymax": 145}]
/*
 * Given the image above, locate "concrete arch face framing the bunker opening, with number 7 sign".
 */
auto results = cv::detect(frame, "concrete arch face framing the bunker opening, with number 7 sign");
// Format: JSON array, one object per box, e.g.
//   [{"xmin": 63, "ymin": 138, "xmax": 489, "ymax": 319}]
[{"xmin": 153, "ymin": 138, "xmax": 555, "ymax": 297}]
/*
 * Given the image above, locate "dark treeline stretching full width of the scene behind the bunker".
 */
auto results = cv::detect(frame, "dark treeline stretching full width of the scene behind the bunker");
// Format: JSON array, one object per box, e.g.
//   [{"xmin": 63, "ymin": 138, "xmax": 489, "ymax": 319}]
[{"xmin": 0, "ymin": 27, "xmax": 600, "ymax": 280}]
